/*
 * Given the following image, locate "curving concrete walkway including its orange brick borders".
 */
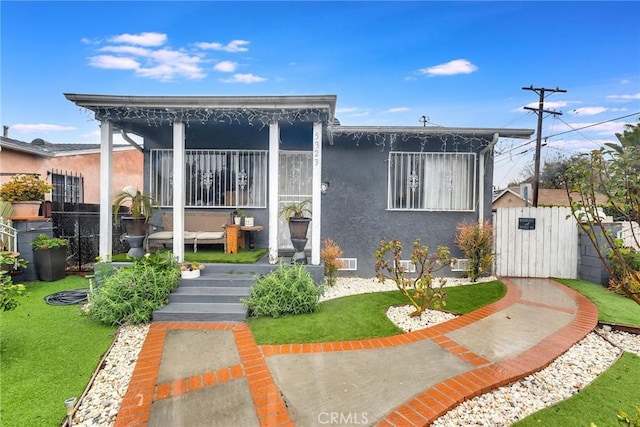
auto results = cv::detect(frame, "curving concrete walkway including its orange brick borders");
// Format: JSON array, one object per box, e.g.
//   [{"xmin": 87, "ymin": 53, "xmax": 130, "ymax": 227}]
[{"xmin": 116, "ymin": 278, "xmax": 598, "ymax": 427}]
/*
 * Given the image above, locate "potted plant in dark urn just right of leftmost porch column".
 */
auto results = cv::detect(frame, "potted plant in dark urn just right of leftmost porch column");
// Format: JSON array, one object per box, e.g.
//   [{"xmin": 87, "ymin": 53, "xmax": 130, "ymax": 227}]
[{"xmin": 113, "ymin": 185, "xmax": 158, "ymax": 236}]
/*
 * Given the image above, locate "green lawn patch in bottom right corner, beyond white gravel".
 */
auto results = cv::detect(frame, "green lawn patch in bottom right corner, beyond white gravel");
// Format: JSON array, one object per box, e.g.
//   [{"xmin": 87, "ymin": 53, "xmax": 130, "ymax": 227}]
[{"xmin": 514, "ymin": 353, "xmax": 640, "ymax": 427}]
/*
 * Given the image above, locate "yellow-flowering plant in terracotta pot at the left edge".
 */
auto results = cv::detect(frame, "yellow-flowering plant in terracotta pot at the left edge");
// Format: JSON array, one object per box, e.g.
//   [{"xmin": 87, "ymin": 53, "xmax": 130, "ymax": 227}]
[{"xmin": 0, "ymin": 174, "xmax": 53, "ymax": 216}]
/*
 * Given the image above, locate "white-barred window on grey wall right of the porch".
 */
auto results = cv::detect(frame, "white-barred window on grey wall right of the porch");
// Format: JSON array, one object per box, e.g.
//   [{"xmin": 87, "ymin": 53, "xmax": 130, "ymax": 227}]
[{"xmin": 387, "ymin": 151, "xmax": 476, "ymax": 211}]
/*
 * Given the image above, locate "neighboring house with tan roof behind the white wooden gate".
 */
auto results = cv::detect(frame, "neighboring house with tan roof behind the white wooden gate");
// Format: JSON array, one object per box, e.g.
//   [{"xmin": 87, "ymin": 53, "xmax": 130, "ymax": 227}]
[{"xmin": 492, "ymin": 184, "xmax": 609, "ymax": 209}]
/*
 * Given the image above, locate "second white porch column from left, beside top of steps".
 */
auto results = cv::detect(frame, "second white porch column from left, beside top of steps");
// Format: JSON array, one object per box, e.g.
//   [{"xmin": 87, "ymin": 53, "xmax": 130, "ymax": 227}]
[{"xmin": 173, "ymin": 122, "xmax": 185, "ymax": 261}]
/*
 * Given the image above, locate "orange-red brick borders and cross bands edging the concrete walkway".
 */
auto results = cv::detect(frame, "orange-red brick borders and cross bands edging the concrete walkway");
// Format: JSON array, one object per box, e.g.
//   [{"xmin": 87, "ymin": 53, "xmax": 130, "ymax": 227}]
[{"xmin": 115, "ymin": 278, "xmax": 598, "ymax": 427}]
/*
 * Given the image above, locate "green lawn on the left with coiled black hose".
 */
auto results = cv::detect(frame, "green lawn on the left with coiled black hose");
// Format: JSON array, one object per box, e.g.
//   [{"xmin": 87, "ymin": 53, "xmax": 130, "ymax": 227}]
[{"xmin": 0, "ymin": 276, "xmax": 115, "ymax": 427}]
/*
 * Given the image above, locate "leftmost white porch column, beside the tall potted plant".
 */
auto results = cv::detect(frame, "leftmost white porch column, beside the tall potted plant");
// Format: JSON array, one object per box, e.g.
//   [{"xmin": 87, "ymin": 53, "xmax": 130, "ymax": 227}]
[{"xmin": 99, "ymin": 120, "xmax": 113, "ymax": 260}]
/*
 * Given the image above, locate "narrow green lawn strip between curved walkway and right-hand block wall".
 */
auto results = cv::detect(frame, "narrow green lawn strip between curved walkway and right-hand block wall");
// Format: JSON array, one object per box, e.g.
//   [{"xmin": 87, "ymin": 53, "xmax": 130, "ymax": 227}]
[{"xmin": 554, "ymin": 279, "xmax": 640, "ymax": 327}]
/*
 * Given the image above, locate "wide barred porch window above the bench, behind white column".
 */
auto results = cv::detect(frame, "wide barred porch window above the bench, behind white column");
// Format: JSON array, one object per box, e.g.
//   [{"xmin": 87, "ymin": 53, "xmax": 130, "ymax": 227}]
[{"xmin": 150, "ymin": 150, "xmax": 268, "ymax": 208}]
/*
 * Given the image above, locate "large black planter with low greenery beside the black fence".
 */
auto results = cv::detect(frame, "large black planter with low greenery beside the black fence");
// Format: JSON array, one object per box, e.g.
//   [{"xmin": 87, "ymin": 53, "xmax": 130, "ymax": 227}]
[{"xmin": 31, "ymin": 233, "xmax": 69, "ymax": 282}]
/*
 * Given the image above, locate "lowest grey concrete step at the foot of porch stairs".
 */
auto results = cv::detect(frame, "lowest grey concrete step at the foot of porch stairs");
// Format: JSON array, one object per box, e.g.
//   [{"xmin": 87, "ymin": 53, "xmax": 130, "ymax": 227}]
[{"xmin": 153, "ymin": 303, "xmax": 247, "ymax": 322}]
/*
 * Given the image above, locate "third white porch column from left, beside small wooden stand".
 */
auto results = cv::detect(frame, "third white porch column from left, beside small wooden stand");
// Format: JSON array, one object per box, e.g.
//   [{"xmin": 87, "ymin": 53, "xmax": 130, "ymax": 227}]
[{"xmin": 268, "ymin": 121, "xmax": 280, "ymax": 264}]
